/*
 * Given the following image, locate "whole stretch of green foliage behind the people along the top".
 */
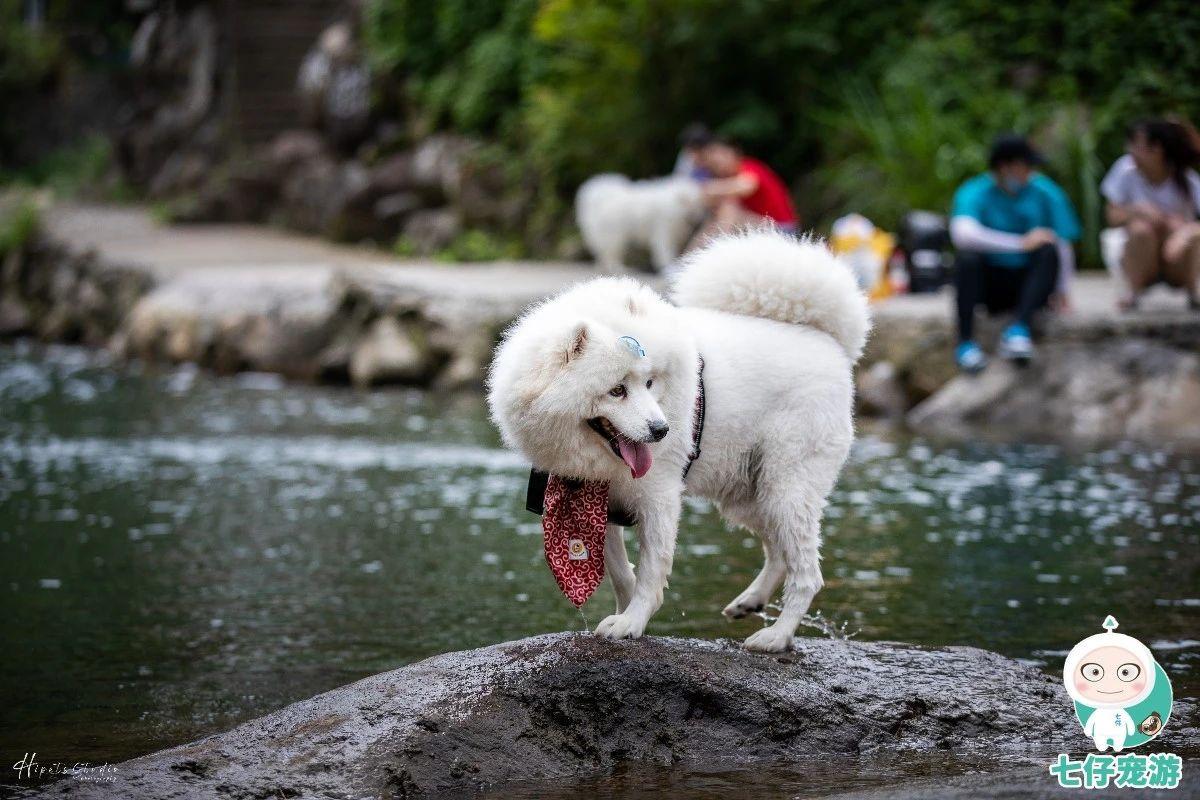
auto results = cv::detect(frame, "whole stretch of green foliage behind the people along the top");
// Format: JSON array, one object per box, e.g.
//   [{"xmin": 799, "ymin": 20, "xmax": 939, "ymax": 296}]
[{"xmin": 367, "ymin": 0, "xmax": 1200, "ymax": 260}]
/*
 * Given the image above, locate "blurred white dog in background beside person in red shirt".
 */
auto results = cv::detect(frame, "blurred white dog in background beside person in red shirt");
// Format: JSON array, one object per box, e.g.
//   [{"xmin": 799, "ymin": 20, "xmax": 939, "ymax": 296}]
[{"xmin": 575, "ymin": 175, "xmax": 704, "ymax": 272}]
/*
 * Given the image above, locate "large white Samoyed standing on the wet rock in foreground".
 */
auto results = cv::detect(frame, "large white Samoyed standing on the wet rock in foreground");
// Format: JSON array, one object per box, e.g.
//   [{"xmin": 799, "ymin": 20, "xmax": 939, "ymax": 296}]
[{"xmin": 488, "ymin": 230, "xmax": 870, "ymax": 652}]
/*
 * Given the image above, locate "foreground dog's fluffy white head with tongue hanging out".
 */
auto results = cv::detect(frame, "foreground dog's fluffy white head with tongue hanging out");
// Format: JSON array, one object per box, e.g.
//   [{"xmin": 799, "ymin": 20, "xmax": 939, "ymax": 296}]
[{"xmin": 488, "ymin": 278, "xmax": 696, "ymax": 481}]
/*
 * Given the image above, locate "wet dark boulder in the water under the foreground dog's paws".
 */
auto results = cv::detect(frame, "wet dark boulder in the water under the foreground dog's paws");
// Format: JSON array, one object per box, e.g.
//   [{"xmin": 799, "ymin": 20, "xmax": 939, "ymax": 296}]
[{"xmin": 43, "ymin": 633, "xmax": 1198, "ymax": 799}]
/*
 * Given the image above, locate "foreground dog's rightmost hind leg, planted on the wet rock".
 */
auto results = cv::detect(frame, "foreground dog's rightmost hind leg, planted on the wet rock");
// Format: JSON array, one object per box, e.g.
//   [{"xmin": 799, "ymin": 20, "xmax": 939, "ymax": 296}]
[{"xmin": 745, "ymin": 487, "xmax": 824, "ymax": 652}]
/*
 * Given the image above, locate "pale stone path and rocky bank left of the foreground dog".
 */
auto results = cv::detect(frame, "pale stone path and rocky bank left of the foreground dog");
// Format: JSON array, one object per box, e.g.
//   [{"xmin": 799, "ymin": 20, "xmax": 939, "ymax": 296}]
[{"xmin": 0, "ymin": 207, "xmax": 594, "ymax": 387}]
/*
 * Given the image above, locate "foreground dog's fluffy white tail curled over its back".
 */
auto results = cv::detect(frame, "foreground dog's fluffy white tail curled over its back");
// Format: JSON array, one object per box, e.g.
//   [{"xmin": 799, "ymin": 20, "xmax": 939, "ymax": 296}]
[{"xmin": 673, "ymin": 229, "xmax": 871, "ymax": 361}]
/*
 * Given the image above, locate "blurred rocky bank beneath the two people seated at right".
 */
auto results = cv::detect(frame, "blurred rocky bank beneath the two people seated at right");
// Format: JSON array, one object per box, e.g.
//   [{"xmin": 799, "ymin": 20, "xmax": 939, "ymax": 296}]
[{"xmin": 858, "ymin": 303, "xmax": 1200, "ymax": 450}]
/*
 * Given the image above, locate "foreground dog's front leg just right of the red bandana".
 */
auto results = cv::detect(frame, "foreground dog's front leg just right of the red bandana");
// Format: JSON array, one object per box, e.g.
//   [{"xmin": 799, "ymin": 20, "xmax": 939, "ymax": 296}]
[{"xmin": 596, "ymin": 487, "xmax": 682, "ymax": 639}]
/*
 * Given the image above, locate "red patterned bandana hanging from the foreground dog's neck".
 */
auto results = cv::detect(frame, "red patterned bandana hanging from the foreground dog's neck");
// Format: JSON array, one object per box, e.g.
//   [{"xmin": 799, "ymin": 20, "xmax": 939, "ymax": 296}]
[{"xmin": 541, "ymin": 475, "xmax": 608, "ymax": 608}]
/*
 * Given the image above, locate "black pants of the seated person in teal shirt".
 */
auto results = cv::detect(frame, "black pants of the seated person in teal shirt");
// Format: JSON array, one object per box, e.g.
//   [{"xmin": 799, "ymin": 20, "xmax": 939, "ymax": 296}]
[{"xmin": 954, "ymin": 245, "xmax": 1058, "ymax": 342}]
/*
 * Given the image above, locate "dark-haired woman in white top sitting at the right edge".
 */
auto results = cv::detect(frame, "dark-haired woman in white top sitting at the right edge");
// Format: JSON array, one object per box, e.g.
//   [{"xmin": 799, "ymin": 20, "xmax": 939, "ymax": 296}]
[{"xmin": 1100, "ymin": 120, "xmax": 1200, "ymax": 309}]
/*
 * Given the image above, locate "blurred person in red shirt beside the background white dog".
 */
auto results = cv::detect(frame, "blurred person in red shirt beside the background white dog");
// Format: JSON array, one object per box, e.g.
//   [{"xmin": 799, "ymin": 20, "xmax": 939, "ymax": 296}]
[{"xmin": 689, "ymin": 138, "xmax": 799, "ymax": 249}]
